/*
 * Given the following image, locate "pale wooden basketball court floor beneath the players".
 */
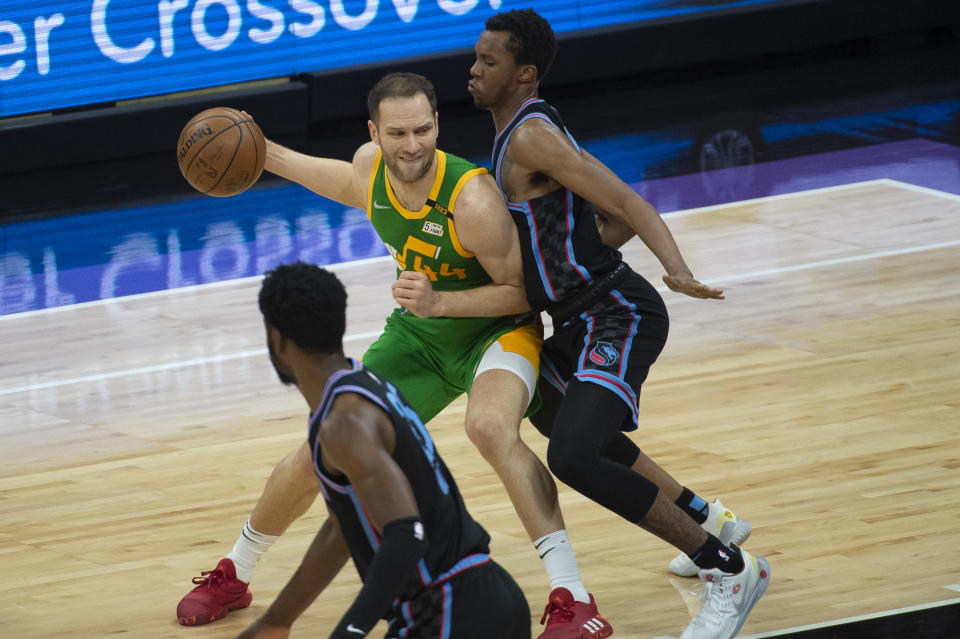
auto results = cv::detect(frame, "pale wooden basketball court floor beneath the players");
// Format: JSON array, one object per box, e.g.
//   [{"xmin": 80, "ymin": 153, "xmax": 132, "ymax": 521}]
[{"xmin": 0, "ymin": 180, "xmax": 960, "ymax": 639}]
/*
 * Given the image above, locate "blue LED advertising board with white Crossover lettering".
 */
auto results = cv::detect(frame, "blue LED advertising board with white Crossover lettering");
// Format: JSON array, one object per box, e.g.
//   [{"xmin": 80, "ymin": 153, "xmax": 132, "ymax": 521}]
[{"xmin": 0, "ymin": 0, "xmax": 790, "ymax": 117}]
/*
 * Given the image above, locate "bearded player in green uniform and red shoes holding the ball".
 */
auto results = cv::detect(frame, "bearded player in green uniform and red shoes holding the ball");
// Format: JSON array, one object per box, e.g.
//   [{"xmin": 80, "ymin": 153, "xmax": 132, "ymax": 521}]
[{"xmin": 177, "ymin": 74, "xmax": 613, "ymax": 639}]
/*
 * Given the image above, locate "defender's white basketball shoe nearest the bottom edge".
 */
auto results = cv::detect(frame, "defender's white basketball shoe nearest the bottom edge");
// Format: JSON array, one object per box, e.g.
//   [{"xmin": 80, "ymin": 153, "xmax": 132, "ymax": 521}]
[{"xmin": 680, "ymin": 550, "xmax": 770, "ymax": 639}]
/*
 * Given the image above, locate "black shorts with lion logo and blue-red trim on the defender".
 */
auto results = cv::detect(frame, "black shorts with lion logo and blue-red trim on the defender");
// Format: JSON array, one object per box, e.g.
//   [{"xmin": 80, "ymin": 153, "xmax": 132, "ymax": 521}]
[{"xmin": 540, "ymin": 271, "xmax": 670, "ymax": 430}]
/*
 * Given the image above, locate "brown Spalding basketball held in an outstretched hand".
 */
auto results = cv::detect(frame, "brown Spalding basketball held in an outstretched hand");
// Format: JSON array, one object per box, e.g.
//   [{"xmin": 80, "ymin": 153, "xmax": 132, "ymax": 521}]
[{"xmin": 177, "ymin": 107, "xmax": 267, "ymax": 197}]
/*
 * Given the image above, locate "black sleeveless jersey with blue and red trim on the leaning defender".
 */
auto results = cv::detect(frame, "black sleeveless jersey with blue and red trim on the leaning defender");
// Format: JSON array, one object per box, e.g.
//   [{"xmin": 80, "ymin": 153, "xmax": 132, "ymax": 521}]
[{"xmin": 492, "ymin": 98, "xmax": 622, "ymax": 311}]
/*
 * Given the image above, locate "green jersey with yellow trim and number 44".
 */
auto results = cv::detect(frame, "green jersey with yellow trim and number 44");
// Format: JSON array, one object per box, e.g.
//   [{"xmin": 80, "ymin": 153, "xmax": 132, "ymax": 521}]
[{"xmin": 367, "ymin": 149, "xmax": 490, "ymax": 291}]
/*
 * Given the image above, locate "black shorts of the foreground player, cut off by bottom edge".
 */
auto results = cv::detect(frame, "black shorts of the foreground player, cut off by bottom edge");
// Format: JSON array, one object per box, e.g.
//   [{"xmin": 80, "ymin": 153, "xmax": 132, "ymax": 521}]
[{"xmin": 386, "ymin": 560, "xmax": 530, "ymax": 639}]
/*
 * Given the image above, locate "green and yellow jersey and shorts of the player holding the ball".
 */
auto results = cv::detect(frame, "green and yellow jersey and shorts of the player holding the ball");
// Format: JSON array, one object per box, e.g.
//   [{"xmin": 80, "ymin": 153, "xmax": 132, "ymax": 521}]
[{"xmin": 363, "ymin": 151, "xmax": 540, "ymax": 422}]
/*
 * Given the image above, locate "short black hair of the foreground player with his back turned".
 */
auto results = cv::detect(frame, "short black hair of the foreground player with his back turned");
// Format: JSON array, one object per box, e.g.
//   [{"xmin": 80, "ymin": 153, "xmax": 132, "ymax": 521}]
[{"xmin": 259, "ymin": 262, "xmax": 347, "ymax": 353}]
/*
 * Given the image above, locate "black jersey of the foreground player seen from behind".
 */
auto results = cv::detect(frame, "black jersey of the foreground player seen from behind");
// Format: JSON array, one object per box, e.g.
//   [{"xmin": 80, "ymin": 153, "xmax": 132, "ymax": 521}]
[{"xmin": 309, "ymin": 360, "xmax": 490, "ymax": 600}]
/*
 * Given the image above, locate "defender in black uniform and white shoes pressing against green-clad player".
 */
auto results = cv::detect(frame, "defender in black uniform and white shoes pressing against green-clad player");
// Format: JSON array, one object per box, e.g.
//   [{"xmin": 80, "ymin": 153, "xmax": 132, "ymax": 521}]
[{"xmin": 436, "ymin": 9, "xmax": 770, "ymax": 639}]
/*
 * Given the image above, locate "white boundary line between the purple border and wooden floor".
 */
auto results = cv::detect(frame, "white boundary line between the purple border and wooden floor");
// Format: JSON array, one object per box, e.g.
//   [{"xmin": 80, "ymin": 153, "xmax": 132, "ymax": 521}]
[{"xmin": 0, "ymin": 178, "xmax": 960, "ymax": 322}]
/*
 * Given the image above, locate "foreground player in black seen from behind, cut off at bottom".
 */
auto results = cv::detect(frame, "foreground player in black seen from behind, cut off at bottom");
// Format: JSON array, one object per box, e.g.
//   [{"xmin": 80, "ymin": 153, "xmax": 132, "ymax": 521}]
[{"xmin": 240, "ymin": 262, "xmax": 530, "ymax": 639}]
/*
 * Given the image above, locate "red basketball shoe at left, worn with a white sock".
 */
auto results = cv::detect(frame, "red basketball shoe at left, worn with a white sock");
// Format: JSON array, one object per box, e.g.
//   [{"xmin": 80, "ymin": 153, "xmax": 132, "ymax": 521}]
[{"xmin": 177, "ymin": 559, "xmax": 253, "ymax": 626}]
